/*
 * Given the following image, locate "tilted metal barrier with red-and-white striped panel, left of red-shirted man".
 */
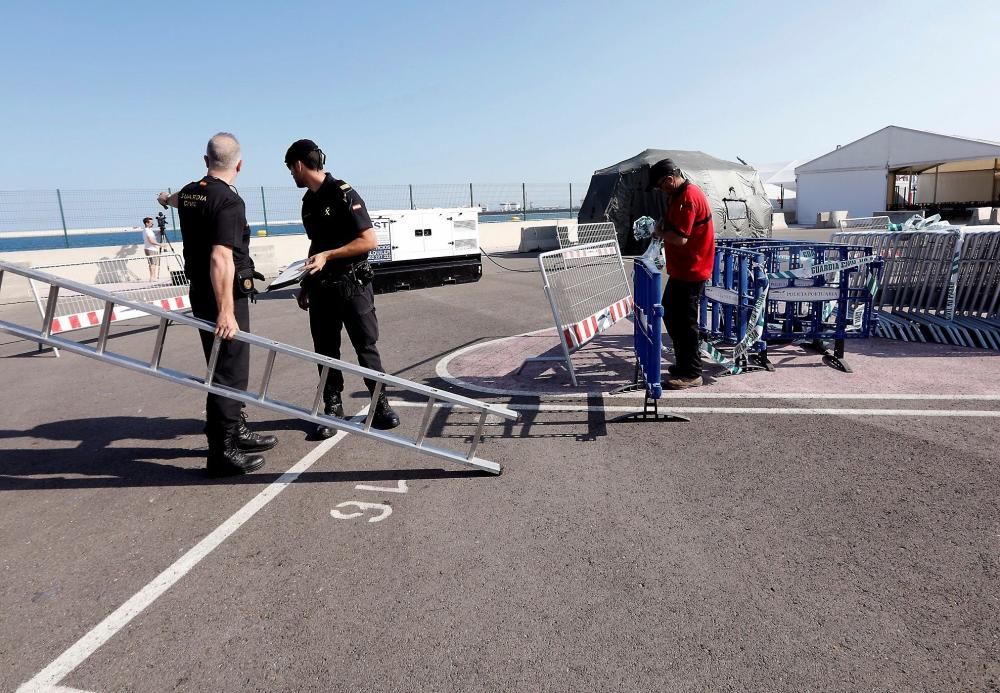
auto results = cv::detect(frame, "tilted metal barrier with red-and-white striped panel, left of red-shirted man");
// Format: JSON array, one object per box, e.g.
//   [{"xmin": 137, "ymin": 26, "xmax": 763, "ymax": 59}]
[{"xmin": 517, "ymin": 238, "xmax": 632, "ymax": 386}]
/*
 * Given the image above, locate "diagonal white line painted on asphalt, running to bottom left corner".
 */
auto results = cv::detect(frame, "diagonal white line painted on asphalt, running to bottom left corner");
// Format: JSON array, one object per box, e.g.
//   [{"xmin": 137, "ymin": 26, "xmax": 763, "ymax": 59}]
[{"xmin": 17, "ymin": 406, "xmax": 368, "ymax": 693}]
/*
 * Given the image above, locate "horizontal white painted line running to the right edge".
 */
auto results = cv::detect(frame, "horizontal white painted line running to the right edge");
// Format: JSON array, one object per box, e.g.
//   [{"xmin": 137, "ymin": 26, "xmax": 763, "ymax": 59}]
[{"xmin": 384, "ymin": 400, "xmax": 1000, "ymax": 416}]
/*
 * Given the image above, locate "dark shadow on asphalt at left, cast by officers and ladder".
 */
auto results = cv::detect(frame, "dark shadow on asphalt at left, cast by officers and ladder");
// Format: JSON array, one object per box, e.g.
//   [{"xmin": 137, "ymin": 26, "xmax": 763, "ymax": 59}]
[{"xmin": 0, "ymin": 416, "xmax": 492, "ymax": 491}]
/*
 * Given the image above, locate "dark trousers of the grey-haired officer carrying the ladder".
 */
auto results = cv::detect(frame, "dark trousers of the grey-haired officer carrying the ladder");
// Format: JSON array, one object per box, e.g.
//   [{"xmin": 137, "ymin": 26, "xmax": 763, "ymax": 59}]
[{"xmin": 191, "ymin": 284, "xmax": 250, "ymax": 440}]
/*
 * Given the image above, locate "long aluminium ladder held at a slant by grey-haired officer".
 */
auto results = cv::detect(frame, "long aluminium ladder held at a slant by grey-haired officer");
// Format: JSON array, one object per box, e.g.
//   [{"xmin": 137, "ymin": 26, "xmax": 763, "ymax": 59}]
[{"xmin": 0, "ymin": 262, "xmax": 518, "ymax": 474}]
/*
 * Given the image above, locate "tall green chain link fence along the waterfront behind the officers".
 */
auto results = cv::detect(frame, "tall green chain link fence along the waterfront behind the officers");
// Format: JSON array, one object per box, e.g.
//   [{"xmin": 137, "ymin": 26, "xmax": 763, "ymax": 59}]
[{"xmin": 0, "ymin": 182, "xmax": 588, "ymax": 251}]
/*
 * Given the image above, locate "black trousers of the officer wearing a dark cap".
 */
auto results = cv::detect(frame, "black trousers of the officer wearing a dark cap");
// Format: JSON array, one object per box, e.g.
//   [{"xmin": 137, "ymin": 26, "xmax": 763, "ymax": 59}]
[{"xmin": 309, "ymin": 284, "xmax": 382, "ymax": 396}]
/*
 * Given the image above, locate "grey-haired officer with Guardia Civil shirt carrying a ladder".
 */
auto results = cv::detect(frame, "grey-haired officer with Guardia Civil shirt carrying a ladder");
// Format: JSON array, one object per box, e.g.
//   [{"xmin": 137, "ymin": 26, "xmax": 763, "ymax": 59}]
[{"xmin": 158, "ymin": 132, "xmax": 278, "ymax": 476}]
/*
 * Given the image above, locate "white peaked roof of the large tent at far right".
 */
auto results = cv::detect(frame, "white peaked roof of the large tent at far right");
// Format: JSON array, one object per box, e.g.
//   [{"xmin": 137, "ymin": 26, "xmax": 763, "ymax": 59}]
[{"xmin": 795, "ymin": 125, "xmax": 1000, "ymax": 175}]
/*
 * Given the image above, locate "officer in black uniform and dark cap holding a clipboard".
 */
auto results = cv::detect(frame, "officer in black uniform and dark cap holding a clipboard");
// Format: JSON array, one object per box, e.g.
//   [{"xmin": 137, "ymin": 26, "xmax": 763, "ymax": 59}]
[{"xmin": 285, "ymin": 140, "xmax": 399, "ymax": 438}]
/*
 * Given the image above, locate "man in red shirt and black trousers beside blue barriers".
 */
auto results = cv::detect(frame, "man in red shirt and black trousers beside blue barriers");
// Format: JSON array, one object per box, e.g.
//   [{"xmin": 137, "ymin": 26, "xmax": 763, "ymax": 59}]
[{"xmin": 647, "ymin": 159, "xmax": 715, "ymax": 390}]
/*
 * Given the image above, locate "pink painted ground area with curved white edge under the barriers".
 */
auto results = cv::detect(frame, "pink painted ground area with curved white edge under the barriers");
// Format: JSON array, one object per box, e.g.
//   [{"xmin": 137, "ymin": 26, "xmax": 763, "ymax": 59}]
[{"xmin": 439, "ymin": 321, "xmax": 1000, "ymax": 398}]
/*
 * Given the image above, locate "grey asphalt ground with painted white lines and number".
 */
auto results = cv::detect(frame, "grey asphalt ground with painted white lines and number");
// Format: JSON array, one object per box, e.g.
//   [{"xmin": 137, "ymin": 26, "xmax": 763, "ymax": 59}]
[{"xmin": 0, "ymin": 256, "xmax": 1000, "ymax": 692}]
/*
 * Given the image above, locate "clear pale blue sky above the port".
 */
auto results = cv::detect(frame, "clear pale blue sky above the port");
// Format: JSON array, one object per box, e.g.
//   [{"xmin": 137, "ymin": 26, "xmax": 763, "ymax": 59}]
[{"xmin": 0, "ymin": 0, "xmax": 1000, "ymax": 190}]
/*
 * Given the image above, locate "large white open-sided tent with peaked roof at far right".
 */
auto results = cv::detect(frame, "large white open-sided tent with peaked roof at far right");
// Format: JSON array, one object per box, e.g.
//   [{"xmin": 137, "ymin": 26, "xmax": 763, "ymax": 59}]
[{"xmin": 795, "ymin": 125, "xmax": 1000, "ymax": 222}]
